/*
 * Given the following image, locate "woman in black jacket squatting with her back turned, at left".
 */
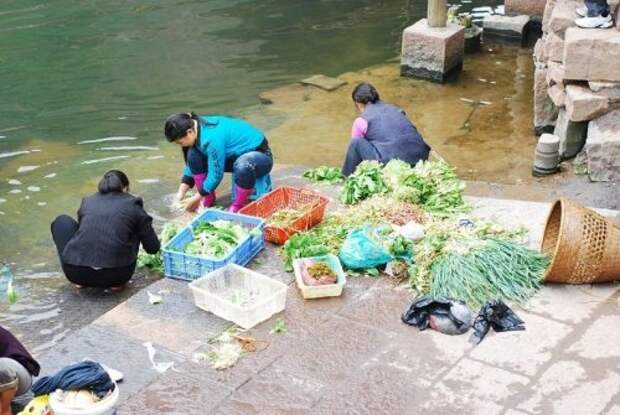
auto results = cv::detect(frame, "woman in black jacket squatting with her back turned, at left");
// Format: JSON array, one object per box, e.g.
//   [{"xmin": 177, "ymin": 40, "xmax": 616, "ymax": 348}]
[{"xmin": 52, "ymin": 170, "xmax": 160, "ymax": 288}]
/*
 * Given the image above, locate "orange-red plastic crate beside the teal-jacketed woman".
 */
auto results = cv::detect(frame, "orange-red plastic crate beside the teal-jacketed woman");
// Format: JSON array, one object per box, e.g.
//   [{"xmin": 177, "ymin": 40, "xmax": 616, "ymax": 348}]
[{"xmin": 239, "ymin": 186, "xmax": 328, "ymax": 245}]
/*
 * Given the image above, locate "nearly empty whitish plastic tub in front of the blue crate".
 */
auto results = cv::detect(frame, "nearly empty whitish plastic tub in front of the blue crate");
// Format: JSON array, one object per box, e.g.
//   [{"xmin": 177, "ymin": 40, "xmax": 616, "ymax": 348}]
[{"xmin": 189, "ymin": 264, "xmax": 288, "ymax": 329}]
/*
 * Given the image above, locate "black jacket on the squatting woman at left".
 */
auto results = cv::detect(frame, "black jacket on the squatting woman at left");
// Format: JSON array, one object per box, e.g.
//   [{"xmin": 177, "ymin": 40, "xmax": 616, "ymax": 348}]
[{"xmin": 62, "ymin": 193, "xmax": 160, "ymax": 268}]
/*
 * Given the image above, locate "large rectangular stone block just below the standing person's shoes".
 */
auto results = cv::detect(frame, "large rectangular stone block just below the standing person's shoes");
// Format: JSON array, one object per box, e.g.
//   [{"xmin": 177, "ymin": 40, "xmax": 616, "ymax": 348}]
[{"xmin": 563, "ymin": 27, "xmax": 620, "ymax": 82}]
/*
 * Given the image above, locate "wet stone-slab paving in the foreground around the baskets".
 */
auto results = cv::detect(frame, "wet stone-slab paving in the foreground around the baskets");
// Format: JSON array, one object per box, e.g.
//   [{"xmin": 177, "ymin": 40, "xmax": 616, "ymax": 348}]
[{"xmin": 32, "ymin": 190, "xmax": 620, "ymax": 415}]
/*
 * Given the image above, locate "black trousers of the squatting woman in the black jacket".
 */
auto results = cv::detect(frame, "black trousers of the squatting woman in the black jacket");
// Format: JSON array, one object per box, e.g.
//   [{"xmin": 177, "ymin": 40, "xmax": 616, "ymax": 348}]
[{"xmin": 52, "ymin": 215, "xmax": 136, "ymax": 288}]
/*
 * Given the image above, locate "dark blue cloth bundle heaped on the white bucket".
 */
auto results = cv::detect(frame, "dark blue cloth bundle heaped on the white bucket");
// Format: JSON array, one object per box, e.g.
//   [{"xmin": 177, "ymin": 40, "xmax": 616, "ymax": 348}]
[{"xmin": 32, "ymin": 360, "xmax": 114, "ymax": 398}]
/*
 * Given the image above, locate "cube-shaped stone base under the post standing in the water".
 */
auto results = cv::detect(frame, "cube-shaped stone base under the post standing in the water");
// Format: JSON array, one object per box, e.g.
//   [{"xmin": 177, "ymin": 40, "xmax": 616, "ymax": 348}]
[{"xmin": 400, "ymin": 19, "xmax": 465, "ymax": 83}]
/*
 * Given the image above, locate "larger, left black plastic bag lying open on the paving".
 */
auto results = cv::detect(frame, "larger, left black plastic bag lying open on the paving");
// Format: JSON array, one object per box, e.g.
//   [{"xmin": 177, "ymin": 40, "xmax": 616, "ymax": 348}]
[{"xmin": 401, "ymin": 296, "xmax": 473, "ymax": 335}]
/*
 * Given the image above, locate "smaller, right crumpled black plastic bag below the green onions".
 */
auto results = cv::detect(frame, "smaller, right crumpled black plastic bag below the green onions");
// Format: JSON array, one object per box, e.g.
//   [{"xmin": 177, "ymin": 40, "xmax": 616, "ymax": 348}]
[{"xmin": 469, "ymin": 300, "xmax": 525, "ymax": 344}]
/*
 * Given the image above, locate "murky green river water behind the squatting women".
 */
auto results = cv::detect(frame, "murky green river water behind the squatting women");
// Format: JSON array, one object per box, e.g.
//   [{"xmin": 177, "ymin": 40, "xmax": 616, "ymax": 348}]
[{"xmin": 0, "ymin": 0, "xmax": 508, "ymax": 352}]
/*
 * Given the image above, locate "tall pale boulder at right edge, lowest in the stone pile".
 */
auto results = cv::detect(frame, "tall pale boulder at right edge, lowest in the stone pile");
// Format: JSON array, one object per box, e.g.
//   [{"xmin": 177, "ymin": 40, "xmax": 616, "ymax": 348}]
[{"xmin": 584, "ymin": 109, "xmax": 620, "ymax": 182}]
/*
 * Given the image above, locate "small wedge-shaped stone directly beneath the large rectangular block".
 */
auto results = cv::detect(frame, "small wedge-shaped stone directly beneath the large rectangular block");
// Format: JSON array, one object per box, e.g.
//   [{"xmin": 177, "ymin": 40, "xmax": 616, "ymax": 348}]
[{"xmin": 565, "ymin": 85, "xmax": 620, "ymax": 121}]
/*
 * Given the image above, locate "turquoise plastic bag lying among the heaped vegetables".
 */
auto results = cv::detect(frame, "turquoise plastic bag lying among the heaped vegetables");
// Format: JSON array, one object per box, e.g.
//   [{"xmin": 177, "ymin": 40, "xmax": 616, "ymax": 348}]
[{"xmin": 338, "ymin": 226, "xmax": 393, "ymax": 269}]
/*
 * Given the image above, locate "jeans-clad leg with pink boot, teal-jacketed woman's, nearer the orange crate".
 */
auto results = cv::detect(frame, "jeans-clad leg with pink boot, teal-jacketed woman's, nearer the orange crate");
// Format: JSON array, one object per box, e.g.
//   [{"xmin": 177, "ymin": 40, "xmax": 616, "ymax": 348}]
[{"xmin": 229, "ymin": 151, "xmax": 273, "ymax": 212}]
